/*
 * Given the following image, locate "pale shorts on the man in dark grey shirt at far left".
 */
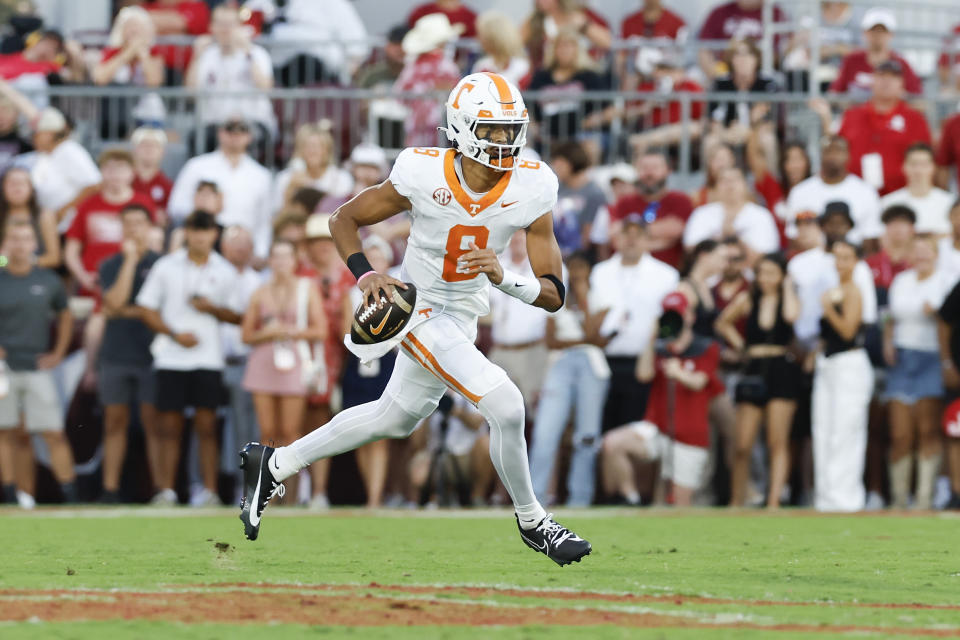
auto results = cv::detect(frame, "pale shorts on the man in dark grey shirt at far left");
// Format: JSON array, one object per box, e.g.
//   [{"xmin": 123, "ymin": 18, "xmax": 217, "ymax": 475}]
[{"xmin": 0, "ymin": 370, "xmax": 63, "ymax": 433}]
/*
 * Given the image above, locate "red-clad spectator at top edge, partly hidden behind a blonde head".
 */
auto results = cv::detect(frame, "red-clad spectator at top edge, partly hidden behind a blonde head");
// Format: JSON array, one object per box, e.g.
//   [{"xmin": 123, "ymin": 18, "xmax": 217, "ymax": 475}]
[{"xmin": 520, "ymin": 0, "xmax": 613, "ymax": 69}]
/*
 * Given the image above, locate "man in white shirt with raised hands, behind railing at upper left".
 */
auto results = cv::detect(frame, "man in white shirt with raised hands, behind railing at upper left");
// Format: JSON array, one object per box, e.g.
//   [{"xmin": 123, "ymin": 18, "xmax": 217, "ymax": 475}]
[{"xmin": 185, "ymin": 4, "xmax": 277, "ymax": 149}]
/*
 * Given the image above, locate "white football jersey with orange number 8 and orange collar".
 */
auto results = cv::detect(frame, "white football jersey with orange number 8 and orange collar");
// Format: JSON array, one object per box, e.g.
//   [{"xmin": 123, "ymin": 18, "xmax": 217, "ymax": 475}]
[{"xmin": 390, "ymin": 147, "xmax": 557, "ymax": 316}]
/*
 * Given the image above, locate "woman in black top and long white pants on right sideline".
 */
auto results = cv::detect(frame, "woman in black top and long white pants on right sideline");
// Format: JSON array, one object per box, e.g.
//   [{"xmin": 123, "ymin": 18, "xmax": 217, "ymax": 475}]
[{"xmin": 811, "ymin": 238, "xmax": 873, "ymax": 511}]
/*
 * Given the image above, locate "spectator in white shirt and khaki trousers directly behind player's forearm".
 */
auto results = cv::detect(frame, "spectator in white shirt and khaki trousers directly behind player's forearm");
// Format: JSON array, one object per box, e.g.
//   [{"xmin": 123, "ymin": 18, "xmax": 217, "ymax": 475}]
[{"xmin": 490, "ymin": 230, "xmax": 547, "ymax": 417}]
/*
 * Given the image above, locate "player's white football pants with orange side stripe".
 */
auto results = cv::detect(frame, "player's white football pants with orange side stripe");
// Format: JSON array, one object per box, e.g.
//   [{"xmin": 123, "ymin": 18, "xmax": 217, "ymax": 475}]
[{"xmin": 386, "ymin": 313, "xmax": 510, "ymax": 418}]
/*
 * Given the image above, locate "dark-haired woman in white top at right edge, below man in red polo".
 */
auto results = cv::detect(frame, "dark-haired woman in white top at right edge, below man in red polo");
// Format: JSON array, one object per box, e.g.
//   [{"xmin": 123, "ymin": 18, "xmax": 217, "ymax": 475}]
[{"xmin": 880, "ymin": 142, "xmax": 955, "ymax": 235}]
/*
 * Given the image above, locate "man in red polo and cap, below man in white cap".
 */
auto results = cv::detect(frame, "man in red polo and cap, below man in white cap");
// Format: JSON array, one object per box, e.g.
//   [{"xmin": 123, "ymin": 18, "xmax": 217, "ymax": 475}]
[{"xmin": 839, "ymin": 60, "xmax": 930, "ymax": 195}]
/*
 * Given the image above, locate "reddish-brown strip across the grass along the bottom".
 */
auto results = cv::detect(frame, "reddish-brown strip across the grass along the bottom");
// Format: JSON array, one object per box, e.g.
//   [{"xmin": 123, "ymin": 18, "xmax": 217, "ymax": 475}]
[{"xmin": 0, "ymin": 583, "xmax": 960, "ymax": 637}]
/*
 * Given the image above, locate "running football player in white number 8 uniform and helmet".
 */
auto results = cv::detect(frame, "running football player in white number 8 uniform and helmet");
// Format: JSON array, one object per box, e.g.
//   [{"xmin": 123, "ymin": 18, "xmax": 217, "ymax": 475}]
[{"xmin": 240, "ymin": 73, "xmax": 591, "ymax": 566}]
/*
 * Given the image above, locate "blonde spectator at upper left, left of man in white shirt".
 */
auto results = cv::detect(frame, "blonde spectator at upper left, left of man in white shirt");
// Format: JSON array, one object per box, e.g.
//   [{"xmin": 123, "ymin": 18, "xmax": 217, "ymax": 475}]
[{"xmin": 90, "ymin": 6, "xmax": 163, "ymax": 87}]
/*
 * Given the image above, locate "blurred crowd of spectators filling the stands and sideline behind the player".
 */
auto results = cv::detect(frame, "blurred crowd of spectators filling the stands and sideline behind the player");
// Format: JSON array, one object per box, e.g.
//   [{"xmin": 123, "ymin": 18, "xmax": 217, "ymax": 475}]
[{"xmin": 0, "ymin": 0, "xmax": 960, "ymax": 511}]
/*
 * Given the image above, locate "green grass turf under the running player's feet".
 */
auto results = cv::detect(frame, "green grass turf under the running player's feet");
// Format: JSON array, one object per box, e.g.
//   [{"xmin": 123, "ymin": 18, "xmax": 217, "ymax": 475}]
[{"xmin": 0, "ymin": 509, "xmax": 960, "ymax": 638}]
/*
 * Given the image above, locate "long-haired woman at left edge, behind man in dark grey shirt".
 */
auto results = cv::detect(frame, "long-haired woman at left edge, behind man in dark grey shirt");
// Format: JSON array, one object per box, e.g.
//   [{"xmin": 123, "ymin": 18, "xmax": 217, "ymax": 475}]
[{"xmin": 0, "ymin": 167, "xmax": 60, "ymax": 269}]
